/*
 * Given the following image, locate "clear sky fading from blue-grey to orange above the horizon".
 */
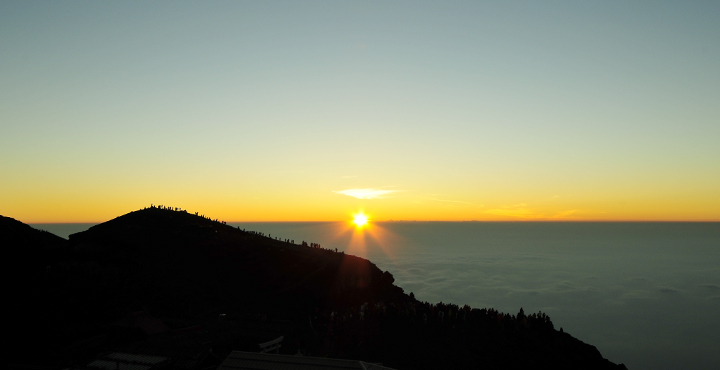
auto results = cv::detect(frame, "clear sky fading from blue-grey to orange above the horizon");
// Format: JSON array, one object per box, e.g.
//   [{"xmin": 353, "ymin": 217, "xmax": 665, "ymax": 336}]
[{"xmin": 0, "ymin": 1, "xmax": 720, "ymax": 223}]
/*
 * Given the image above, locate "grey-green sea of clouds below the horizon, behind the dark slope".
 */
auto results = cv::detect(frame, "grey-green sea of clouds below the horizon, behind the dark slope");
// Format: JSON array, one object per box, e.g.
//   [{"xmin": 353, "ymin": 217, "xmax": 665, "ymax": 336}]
[{"xmin": 34, "ymin": 222, "xmax": 720, "ymax": 370}]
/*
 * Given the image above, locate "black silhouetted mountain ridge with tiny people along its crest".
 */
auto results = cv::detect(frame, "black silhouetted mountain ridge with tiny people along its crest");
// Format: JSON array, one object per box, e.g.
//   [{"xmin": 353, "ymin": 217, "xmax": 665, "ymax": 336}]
[{"xmin": 0, "ymin": 206, "xmax": 624, "ymax": 369}]
